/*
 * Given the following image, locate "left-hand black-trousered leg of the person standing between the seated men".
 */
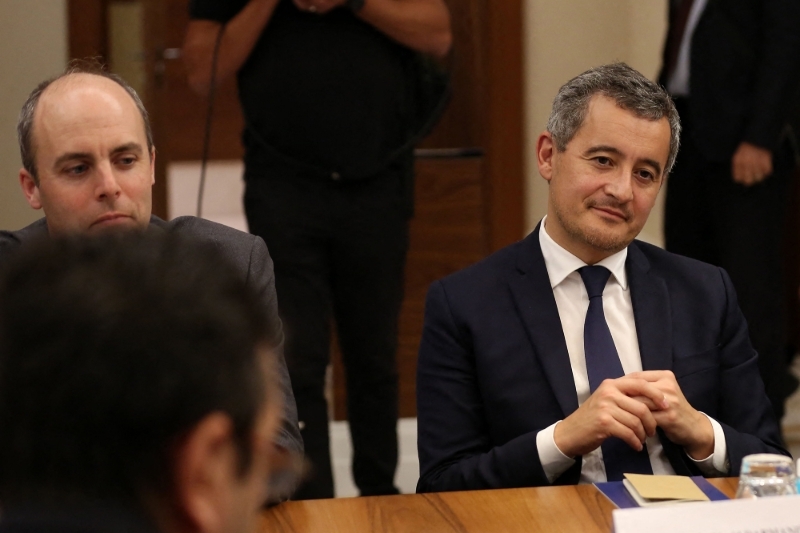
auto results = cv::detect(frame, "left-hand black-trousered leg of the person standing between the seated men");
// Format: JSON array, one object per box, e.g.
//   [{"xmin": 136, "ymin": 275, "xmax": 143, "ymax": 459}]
[{"xmin": 245, "ymin": 172, "xmax": 334, "ymax": 500}]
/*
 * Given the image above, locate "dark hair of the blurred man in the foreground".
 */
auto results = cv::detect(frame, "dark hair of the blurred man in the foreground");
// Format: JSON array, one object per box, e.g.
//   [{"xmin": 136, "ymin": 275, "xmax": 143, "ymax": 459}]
[{"xmin": 0, "ymin": 234, "xmax": 270, "ymax": 505}]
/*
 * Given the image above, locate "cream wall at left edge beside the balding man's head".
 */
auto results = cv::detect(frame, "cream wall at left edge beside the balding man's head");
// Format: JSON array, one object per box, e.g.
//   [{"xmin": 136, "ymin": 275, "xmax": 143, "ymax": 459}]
[{"xmin": 0, "ymin": 0, "xmax": 67, "ymax": 229}]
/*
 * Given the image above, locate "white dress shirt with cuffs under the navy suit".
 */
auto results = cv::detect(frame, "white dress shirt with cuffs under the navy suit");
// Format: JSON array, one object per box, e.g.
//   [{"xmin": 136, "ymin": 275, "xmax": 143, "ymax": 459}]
[{"xmin": 536, "ymin": 217, "xmax": 728, "ymax": 483}]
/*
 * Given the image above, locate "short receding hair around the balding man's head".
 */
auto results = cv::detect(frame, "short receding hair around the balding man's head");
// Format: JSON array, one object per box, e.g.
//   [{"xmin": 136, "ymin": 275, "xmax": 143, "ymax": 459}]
[{"xmin": 17, "ymin": 59, "xmax": 153, "ymax": 185}]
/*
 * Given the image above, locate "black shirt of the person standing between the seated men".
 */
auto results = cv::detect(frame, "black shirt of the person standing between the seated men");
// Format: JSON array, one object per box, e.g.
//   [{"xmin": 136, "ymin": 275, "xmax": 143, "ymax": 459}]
[{"xmin": 190, "ymin": 0, "xmax": 414, "ymax": 178}]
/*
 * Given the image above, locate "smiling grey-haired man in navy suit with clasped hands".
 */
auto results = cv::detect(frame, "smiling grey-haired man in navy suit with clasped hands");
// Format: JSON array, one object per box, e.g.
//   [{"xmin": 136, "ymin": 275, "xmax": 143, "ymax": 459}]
[{"xmin": 417, "ymin": 64, "xmax": 787, "ymax": 492}]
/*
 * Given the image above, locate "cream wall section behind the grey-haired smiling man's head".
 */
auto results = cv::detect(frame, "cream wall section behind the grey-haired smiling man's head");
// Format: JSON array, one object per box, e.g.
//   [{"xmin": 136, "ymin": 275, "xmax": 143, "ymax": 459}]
[{"xmin": 524, "ymin": 0, "xmax": 667, "ymax": 244}]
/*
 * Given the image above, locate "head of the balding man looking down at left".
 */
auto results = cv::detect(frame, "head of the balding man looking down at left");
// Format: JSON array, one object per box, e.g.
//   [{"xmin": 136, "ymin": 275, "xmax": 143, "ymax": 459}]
[{"xmin": 17, "ymin": 62, "xmax": 155, "ymax": 235}]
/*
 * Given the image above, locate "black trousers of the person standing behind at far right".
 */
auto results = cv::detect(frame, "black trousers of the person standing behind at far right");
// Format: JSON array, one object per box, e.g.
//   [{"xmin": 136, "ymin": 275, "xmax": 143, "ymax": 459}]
[{"xmin": 664, "ymin": 100, "xmax": 797, "ymax": 421}]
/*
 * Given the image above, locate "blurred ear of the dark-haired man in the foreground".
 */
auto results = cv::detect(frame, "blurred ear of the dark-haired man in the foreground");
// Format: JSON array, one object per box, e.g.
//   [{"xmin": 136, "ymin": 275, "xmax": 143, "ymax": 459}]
[{"xmin": 173, "ymin": 412, "xmax": 238, "ymax": 533}]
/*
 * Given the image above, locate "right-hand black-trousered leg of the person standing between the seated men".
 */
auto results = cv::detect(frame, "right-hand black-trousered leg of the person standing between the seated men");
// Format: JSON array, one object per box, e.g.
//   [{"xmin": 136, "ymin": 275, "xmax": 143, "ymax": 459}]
[{"xmin": 332, "ymin": 157, "xmax": 410, "ymax": 496}]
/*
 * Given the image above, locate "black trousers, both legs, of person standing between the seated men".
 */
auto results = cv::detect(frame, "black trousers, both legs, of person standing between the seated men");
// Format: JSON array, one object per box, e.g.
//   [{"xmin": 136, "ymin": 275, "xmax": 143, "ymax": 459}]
[{"xmin": 244, "ymin": 157, "xmax": 413, "ymax": 499}]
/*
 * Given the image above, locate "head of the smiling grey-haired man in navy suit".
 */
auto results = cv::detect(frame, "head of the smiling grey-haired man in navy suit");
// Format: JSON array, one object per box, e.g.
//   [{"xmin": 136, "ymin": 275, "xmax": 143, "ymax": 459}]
[{"xmin": 537, "ymin": 63, "xmax": 680, "ymax": 264}]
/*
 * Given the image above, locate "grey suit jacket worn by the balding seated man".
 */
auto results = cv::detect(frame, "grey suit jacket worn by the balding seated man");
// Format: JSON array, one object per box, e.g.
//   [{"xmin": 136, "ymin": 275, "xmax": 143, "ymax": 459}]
[{"xmin": 0, "ymin": 216, "xmax": 303, "ymax": 495}]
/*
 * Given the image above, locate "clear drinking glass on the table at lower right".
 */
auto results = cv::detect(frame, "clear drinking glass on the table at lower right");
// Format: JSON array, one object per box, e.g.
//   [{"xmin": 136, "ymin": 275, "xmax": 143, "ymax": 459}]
[{"xmin": 736, "ymin": 453, "xmax": 797, "ymax": 498}]
